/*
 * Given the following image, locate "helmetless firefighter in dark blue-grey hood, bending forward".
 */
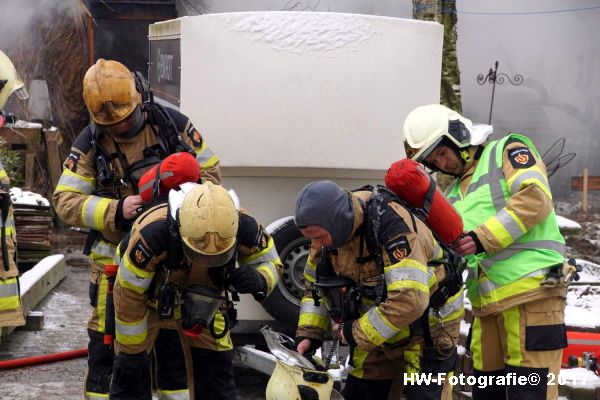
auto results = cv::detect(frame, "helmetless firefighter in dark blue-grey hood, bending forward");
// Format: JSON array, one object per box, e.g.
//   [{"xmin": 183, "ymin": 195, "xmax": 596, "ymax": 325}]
[{"xmin": 295, "ymin": 181, "xmax": 464, "ymax": 399}]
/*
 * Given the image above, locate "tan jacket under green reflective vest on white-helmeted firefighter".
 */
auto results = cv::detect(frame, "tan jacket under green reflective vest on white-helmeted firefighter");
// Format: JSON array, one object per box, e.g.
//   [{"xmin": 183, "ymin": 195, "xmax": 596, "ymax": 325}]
[{"xmin": 447, "ymin": 134, "xmax": 566, "ymax": 317}]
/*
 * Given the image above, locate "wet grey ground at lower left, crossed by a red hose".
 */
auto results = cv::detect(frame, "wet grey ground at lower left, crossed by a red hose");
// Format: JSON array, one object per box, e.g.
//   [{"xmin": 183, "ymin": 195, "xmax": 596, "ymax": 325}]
[{"xmin": 0, "ymin": 230, "xmax": 269, "ymax": 400}]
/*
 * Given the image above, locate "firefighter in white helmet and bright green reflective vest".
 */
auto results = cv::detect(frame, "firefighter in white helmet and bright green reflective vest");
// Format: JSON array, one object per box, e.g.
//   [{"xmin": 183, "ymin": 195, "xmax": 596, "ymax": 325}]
[{"xmin": 403, "ymin": 104, "xmax": 574, "ymax": 400}]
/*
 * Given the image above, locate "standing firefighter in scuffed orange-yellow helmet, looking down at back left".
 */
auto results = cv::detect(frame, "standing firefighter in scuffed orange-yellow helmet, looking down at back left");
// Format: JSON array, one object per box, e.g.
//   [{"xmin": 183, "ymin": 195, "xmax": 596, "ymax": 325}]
[{"xmin": 53, "ymin": 59, "xmax": 220, "ymax": 399}]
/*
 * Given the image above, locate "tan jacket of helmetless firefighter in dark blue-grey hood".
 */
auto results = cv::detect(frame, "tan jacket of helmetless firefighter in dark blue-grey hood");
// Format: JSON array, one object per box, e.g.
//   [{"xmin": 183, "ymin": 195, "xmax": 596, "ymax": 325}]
[{"xmin": 296, "ymin": 191, "xmax": 464, "ymax": 351}]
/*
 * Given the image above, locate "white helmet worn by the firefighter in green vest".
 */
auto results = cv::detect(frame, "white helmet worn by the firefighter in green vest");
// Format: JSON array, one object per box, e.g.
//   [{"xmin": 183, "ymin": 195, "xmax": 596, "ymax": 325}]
[{"xmin": 402, "ymin": 104, "xmax": 492, "ymax": 162}]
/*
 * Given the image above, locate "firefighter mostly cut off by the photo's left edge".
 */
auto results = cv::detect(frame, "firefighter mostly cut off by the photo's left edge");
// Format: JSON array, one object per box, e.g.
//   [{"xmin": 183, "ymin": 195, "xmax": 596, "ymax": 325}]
[{"xmin": 0, "ymin": 51, "xmax": 28, "ymax": 329}]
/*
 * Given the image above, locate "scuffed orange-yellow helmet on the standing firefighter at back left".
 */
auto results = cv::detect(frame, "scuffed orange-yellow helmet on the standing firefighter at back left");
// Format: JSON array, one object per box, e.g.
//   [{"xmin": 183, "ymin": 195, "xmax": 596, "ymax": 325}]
[{"xmin": 83, "ymin": 58, "xmax": 142, "ymax": 125}]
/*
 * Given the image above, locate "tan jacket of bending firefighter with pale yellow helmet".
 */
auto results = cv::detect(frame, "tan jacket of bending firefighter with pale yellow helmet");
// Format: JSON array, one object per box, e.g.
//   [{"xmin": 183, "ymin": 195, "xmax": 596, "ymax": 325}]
[{"xmin": 113, "ymin": 203, "xmax": 281, "ymax": 353}]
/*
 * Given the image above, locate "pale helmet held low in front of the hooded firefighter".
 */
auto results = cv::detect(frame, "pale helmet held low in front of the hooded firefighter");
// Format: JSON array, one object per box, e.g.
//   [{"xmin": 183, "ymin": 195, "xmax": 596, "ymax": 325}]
[{"xmin": 261, "ymin": 328, "xmax": 343, "ymax": 400}]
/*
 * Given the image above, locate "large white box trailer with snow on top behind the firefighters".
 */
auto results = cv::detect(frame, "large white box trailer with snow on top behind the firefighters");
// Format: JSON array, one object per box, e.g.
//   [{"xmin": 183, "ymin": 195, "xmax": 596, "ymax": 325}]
[{"xmin": 149, "ymin": 12, "xmax": 443, "ymax": 318}]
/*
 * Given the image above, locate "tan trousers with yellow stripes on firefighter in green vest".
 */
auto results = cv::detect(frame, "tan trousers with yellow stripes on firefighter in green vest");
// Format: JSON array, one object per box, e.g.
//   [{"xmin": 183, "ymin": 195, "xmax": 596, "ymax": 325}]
[{"xmin": 470, "ymin": 297, "xmax": 567, "ymax": 400}]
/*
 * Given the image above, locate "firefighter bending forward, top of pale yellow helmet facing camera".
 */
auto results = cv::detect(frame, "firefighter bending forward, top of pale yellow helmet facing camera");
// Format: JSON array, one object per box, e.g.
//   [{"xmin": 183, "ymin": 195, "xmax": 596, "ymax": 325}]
[{"xmin": 110, "ymin": 182, "xmax": 280, "ymax": 400}]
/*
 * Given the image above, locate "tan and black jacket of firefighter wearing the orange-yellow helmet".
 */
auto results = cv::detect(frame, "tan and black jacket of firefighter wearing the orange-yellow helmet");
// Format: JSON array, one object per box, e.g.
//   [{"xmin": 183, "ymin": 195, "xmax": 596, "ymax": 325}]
[{"xmin": 52, "ymin": 108, "xmax": 221, "ymax": 268}]
